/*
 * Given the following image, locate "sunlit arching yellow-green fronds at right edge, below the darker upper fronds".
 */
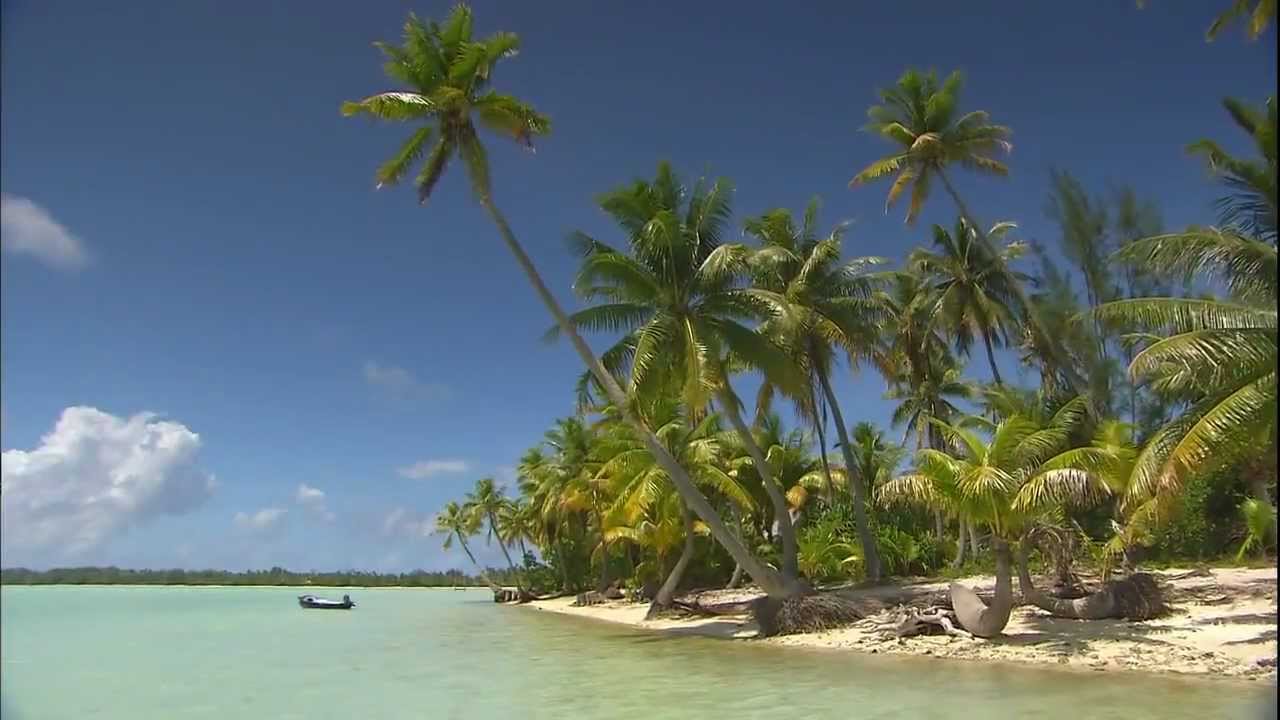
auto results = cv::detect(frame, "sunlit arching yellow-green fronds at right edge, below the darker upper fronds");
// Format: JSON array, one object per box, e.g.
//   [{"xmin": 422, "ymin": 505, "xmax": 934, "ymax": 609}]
[{"xmin": 1097, "ymin": 228, "xmax": 1276, "ymax": 515}]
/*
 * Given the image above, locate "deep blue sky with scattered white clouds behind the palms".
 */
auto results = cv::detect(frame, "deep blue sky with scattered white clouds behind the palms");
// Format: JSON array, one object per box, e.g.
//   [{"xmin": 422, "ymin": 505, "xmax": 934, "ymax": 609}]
[{"xmin": 0, "ymin": 0, "xmax": 1276, "ymax": 570}]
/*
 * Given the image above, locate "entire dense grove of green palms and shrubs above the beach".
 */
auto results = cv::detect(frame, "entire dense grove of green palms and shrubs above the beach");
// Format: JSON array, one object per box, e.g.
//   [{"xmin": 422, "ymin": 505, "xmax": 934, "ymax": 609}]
[{"xmin": 343, "ymin": 1, "xmax": 1276, "ymax": 635}]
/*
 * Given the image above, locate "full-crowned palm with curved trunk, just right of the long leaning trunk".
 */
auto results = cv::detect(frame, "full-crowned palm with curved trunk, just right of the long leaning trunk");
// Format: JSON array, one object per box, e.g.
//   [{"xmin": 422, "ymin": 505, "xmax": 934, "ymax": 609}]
[{"xmin": 558, "ymin": 163, "xmax": 796, "ymax": 579}]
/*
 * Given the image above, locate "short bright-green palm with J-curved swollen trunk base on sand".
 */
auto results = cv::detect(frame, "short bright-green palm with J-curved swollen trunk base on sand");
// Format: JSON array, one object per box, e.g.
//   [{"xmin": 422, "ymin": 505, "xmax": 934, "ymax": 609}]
[{"xmin": 877, "ymin": 398, "xmax": 1123, "ymax": 637}]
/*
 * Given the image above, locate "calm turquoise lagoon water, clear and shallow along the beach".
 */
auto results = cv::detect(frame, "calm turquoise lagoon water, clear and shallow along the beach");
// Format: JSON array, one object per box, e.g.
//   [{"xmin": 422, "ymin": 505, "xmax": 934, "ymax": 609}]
[{"xmin": 0, "ymin": 587, "xmax": 1275, "ymax": 720}]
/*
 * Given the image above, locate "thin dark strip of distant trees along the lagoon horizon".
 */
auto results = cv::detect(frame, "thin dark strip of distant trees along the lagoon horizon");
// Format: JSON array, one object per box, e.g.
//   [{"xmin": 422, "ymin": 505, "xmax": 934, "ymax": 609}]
[{"xmin": 0, "ymin": 568, "xmax": 519, "ymax": 588}]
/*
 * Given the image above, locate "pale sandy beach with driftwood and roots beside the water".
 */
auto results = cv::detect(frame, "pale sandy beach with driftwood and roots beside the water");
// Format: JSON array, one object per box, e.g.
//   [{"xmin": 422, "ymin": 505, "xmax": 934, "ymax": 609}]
[{"xmin": 525, "ymin": 568, "xmax": 1277, "ymax": 683}]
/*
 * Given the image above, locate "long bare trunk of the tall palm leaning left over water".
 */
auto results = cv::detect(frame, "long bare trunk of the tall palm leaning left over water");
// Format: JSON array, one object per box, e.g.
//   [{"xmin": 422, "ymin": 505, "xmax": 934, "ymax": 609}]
[{"xmin": 480, "ymin": 193, "xmax": 805, "ymax": 598}]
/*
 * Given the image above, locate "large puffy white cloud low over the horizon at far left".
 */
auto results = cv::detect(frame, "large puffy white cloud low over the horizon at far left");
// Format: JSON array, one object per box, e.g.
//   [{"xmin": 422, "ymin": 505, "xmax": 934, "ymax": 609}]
[{"xmin": 0, "ymin": 407, "xmax": 218, "ymax": 566}]
